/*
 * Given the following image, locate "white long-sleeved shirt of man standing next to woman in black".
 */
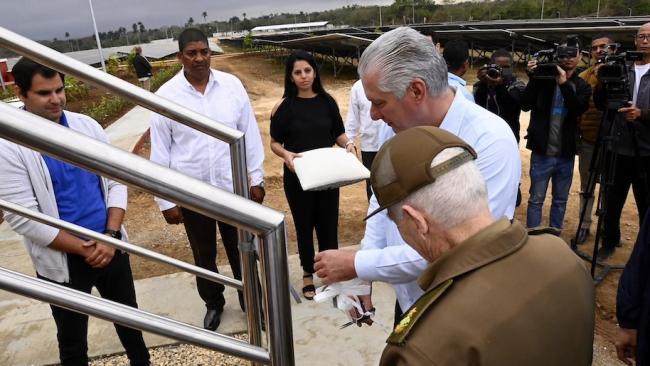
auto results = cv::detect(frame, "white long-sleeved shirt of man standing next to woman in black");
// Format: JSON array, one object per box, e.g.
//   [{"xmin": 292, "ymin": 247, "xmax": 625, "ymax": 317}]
[{"xmin": 151, "ymin": 70, "xmax": 264, "ymax": 211}]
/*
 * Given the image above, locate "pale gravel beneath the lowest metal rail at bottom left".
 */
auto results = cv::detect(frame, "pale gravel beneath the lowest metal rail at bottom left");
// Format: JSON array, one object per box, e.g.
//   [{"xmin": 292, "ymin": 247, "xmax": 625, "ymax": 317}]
[{"xmin": 90, "ymin": 334, "xmax": 250, "ymax": 366}]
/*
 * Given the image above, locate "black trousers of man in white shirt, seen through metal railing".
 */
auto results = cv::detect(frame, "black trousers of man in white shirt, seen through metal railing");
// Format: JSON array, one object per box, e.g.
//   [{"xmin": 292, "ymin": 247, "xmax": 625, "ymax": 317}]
[{"xmin": 181, "ymin": 208, "xmax": 243, "ymax": 310}]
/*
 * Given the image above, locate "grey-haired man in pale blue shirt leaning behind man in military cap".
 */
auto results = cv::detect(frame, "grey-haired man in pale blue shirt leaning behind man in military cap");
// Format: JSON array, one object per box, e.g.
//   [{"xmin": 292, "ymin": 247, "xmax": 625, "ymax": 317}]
[{"xmin": 314, "ymin": 27, "xmax": 521, "ymax": 319}]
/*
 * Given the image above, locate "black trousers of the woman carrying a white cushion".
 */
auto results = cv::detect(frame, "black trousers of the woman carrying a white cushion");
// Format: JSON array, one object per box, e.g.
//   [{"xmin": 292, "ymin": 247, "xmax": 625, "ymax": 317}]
[{"xmin": 283, "ymin": 166, "xmax": 339, "ymax": 273}]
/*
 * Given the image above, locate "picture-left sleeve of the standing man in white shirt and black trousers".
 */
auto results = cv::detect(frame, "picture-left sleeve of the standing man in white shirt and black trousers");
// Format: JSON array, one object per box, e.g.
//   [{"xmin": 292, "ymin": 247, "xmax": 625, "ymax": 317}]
[{"xmin": 149, "ymin": 113, "xmax": 176, "ymax": 211}]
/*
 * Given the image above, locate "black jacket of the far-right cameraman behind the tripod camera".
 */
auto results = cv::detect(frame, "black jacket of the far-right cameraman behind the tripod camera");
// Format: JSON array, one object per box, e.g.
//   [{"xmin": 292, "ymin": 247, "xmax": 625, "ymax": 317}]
[{"xmin": 594, "ymin": 64, "xmax": 650, "ymax": 156}]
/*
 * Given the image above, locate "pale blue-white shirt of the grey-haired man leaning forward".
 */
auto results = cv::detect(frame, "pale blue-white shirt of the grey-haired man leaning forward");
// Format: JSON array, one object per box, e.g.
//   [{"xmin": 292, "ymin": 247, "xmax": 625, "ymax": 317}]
[{"xmin": 354, "ymin": 87, "xmax": 521, "ymax": 311}]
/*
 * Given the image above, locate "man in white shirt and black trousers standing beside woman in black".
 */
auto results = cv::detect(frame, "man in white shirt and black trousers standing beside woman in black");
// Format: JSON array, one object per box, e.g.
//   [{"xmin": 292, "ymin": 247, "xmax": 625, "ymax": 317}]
[{"xmin": 151, "ymin": 28, "xmax": 265, "ymax": 330}]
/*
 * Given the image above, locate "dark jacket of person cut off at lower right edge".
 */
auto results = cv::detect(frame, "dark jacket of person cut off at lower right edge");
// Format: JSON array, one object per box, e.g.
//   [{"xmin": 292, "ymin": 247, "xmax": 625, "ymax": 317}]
[{"xmin": 616, "ymin": 214, "xmax": 650, "ymax": 366}]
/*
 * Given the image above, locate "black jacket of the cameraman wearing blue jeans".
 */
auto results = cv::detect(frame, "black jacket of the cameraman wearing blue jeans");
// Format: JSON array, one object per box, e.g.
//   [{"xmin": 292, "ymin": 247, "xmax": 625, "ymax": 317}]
[{"xmin": 521, "ymin": 72, "xmax": 591, "ymax": 157}]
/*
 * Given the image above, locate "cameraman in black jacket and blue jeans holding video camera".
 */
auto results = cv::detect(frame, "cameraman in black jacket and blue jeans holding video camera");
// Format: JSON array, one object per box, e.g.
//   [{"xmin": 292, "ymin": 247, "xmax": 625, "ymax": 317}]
[{"xmin": 521, "ymin": 37, "xmax": 591, "ymax": 231}]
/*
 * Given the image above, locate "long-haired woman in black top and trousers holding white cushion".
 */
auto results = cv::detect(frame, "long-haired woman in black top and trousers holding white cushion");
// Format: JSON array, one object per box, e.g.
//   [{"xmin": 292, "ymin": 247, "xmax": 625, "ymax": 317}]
[{"xmin": 271, "ymin": 51, "xmax": 355, "ymax": 300}]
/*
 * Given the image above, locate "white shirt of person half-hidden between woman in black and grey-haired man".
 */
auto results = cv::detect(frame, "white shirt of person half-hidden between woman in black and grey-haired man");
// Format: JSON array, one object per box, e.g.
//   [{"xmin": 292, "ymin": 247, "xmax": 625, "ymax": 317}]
[{"xmin": 345, "ymin": 80, "xmax": 384, "ymax": 152}]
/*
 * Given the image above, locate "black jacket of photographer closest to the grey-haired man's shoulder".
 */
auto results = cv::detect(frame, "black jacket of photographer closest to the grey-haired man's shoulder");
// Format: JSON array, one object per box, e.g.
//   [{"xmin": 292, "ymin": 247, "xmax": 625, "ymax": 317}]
[{"xmin": 474, "ymin": 78, "xmax": 526, "ymax": 142}]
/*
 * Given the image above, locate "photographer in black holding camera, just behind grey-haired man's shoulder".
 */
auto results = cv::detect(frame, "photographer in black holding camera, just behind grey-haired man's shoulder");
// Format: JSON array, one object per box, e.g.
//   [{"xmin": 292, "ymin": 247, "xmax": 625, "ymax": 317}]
[{"xmin": 474, "ymin": 48, "xmax": 526, "ymax": 142}]
